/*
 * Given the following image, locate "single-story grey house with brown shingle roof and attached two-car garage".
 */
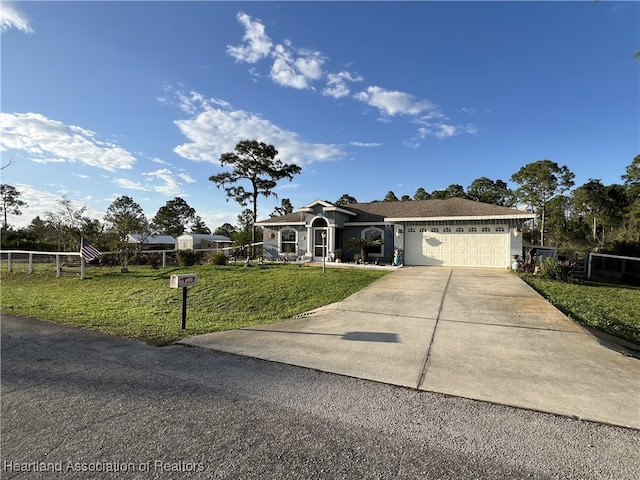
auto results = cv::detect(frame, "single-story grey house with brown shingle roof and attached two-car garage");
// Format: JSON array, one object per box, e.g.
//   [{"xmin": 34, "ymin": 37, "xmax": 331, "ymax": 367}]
[{"xmin": 256, "ymin": 198, "xmax": 535, "ymax": 268}]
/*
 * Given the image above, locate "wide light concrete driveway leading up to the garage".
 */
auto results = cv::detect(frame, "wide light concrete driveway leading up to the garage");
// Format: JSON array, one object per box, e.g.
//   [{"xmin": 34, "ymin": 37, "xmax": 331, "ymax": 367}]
[{"xmin": 181, "ymin": 267, "xmax": 640, "ymax": 429}]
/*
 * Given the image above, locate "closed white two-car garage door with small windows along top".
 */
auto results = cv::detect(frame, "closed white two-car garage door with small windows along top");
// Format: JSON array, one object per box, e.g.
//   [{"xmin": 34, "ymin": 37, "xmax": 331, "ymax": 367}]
[{"xmin": 405, "ymin": 225, "xmax": 510, "ymax": 268}]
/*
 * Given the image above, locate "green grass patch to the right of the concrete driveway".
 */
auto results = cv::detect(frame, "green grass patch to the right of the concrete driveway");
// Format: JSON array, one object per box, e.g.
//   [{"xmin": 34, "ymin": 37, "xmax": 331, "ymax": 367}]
[{"xmin": 522, "ymin": 275, "xmax": 640, "ymax": 345}]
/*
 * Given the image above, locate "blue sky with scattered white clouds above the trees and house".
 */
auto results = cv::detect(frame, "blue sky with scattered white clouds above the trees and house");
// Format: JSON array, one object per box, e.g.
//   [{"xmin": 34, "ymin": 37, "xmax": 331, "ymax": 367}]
[{"xmin": 0, "ymin": 1, "xmax": 640, "ymax": 230}]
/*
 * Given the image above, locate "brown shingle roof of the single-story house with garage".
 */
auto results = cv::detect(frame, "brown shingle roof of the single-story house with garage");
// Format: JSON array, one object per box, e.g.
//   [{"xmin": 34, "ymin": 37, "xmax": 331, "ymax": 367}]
[{"xmin": 259, "ymin": 198, "xmax": 534, "ymax": 225}]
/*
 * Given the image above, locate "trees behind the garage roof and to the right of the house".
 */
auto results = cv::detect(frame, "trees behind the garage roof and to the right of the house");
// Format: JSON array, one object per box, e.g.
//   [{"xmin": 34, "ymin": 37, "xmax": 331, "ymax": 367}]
[{"xmin": 334, "ymin": 155, "xmax": 640, "ymax": 255}]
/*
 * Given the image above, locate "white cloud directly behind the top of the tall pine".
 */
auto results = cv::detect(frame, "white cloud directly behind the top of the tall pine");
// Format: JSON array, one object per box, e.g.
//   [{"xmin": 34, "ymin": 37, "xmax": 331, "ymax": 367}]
[{"xmin": 168, "ymin": 87, "xmax": 343, "ymax": 166}]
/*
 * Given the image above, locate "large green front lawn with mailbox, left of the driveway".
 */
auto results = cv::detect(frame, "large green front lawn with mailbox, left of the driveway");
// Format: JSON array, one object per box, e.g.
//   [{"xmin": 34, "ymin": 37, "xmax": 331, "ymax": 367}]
[{"xmin": 0, "ymin": 264, "xmax": 388, "ymax": 345}]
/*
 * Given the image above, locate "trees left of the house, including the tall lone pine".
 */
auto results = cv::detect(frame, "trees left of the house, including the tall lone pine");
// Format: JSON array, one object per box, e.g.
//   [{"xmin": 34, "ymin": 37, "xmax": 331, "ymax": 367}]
[{"xmin": 0, "ymin": 140, "xmax": 301, "ymax": 258}]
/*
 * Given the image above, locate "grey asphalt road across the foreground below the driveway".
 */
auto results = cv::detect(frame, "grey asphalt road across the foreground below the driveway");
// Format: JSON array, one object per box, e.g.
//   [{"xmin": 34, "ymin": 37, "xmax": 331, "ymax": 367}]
[{"xmin": 0, "ymin": 316, "xmax": 640, "ymax": 479}]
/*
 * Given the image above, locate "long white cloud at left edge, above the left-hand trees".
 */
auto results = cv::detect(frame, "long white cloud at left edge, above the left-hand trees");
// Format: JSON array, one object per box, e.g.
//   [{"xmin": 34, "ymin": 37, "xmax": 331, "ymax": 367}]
[{"xmin": 0, "ymin": 113, "xmax": 136, "ymax": 172}]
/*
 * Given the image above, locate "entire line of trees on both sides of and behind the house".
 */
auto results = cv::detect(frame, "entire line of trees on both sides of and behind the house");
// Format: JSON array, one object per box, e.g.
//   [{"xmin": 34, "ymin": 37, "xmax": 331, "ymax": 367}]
[{"xmin": 0, "ymin": 140, "xmax": 640, "ymax": 255}]
